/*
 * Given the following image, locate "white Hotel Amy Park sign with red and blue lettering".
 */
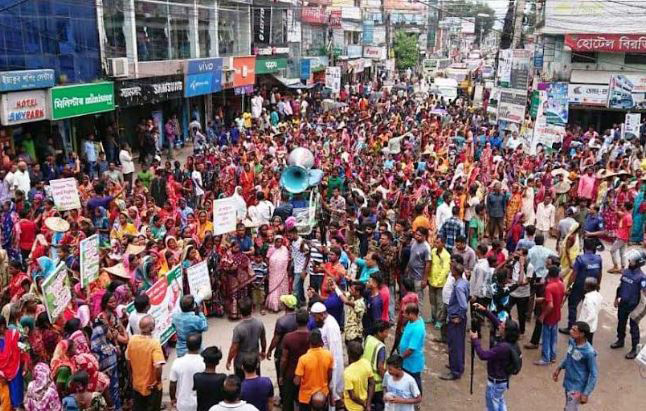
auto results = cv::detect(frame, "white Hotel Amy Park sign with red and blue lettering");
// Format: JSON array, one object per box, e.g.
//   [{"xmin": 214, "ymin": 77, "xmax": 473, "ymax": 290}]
[{"xmin": 0, "ymin": 90, "xmax": 47, "ymax": 126}]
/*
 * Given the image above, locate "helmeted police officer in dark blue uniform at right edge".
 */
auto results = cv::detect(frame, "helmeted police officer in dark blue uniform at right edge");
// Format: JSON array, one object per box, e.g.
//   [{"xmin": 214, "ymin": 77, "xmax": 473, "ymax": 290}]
[{"xmin": 610, "ymin": 250, "xmax": 646, "ymax": 360}]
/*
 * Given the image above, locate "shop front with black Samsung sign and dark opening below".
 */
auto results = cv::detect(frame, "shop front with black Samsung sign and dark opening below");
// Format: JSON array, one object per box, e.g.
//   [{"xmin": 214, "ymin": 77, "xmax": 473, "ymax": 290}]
[{"xmin": 115, "ymin": 74, "xmax": 188, "ymax": 151}]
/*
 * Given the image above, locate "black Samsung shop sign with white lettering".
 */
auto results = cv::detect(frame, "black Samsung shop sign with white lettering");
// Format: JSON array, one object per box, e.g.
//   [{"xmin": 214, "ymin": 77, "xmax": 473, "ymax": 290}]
[{"xmin": 116, "ymin": 74, "xmax": 184, "ymax": 107}]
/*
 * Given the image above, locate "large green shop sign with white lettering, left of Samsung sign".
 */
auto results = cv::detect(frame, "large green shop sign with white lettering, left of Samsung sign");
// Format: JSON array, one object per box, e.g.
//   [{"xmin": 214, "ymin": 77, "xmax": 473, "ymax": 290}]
[{"xmin": 51, "ymin": 81, "xmax": 114, "ymax": 120}]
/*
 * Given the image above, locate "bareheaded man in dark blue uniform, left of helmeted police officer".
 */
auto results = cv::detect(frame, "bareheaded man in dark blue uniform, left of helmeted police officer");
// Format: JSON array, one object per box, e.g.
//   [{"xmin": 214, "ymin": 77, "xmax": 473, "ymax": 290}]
[{"xmin": 559, "ymin": 238, "xmax": 602, "ymax": 334}]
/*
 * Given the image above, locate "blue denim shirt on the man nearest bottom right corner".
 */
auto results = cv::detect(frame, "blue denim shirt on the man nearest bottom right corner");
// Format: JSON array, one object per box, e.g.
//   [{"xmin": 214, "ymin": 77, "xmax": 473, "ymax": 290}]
[{"xmin": 559, "ymin": 338, "xmax": 598, "ymax": 395}]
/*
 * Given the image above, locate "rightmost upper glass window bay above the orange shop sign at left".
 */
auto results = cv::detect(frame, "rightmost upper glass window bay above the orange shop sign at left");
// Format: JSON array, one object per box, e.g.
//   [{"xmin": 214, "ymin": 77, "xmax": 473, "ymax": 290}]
[{"xmin": 218, "ymin": 2, "xmax": 251, "ymax": 56}]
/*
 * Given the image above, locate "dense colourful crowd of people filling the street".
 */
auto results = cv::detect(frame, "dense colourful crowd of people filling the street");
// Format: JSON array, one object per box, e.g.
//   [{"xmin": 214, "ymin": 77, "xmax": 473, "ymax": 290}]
[{"xmin": 0, "ymin": 75, "xmax": 646, "ymax": 411}]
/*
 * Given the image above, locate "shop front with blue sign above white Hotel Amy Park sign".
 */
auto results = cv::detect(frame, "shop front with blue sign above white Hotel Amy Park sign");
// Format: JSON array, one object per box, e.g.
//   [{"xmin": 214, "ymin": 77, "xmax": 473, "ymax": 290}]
[{"xmin": 0, "ymin": 70, "xmax": 56, "ymax": 161}]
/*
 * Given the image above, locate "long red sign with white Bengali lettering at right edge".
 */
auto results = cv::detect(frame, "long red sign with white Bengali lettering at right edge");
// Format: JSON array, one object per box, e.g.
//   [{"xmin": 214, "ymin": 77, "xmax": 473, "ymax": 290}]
[{"xmin": 565, "ymin": 34, "xmax": 646, "ymax": 53}]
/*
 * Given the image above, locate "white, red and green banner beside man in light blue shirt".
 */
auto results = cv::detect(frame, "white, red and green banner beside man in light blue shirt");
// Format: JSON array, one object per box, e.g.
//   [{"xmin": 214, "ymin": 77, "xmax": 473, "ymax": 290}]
[{"xmin": 126, "ymin": 265, "xmax": 182, "ymax": 345}]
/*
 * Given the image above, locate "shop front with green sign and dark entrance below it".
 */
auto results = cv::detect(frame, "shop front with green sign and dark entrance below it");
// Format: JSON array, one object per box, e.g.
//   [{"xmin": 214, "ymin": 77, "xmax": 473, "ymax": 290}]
[{"xmin": 48, "ymin": 81, "xmax": 115, "ymax": 154}]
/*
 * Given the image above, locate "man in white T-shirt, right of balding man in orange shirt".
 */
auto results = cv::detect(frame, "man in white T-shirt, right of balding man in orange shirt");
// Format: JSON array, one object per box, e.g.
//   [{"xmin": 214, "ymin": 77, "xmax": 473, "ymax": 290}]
[{"xmin": 169, "ymin": 333, "xmax": 206, "ymax": 411}]
